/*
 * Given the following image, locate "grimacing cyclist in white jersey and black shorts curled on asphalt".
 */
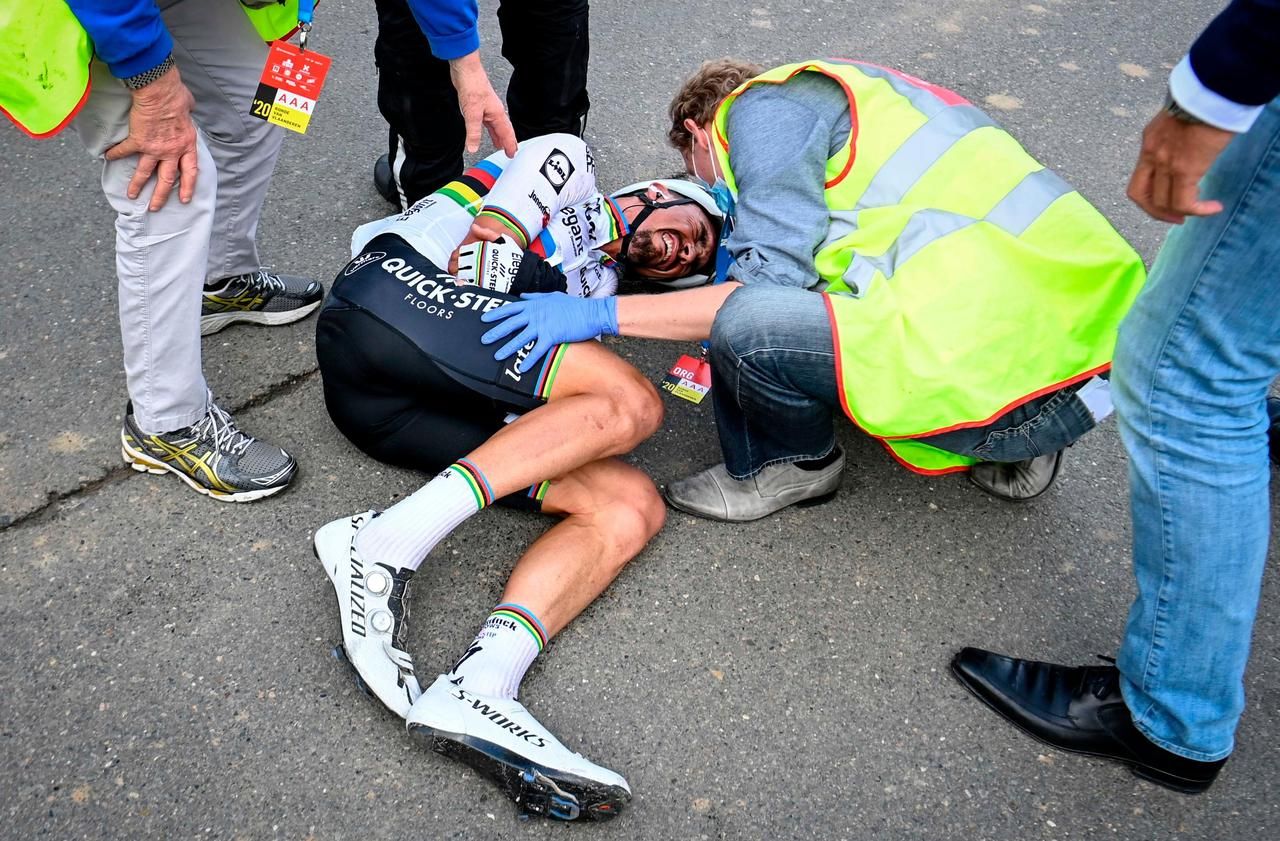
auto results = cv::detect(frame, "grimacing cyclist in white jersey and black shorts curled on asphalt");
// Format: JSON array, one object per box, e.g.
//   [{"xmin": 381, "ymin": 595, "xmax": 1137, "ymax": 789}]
[{"xmin": 315, "ymin": 134, "xmax": 723, "ymax": 821}]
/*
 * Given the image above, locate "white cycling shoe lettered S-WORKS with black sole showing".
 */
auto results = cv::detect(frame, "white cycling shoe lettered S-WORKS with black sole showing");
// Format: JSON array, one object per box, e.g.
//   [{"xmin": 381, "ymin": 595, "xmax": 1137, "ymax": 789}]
[{"xmin": 407, "ymin": 675, "xmax": 631, "ymax": 821}]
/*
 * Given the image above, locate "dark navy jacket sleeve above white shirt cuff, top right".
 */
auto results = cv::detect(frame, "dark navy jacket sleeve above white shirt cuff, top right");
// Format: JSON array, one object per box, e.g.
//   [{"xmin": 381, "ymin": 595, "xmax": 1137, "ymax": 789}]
[{"xmin": 1190, "ymin": 0, "xmax": 1280, "ymax": 105}]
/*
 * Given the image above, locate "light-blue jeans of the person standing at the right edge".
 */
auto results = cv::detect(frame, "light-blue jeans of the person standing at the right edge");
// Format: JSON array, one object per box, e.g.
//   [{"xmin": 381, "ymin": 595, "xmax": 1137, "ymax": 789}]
[{"xmin": 1115, "ymin": 100, "xmax": 1280, "ymax": 762}]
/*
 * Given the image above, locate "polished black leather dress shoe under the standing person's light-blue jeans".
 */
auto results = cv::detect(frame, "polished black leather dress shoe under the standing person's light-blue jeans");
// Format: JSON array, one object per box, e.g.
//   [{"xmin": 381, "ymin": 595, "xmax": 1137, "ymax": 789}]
[{"xmin": 951, "ymin": 648, "xmax": 1226, "ymax": 794}]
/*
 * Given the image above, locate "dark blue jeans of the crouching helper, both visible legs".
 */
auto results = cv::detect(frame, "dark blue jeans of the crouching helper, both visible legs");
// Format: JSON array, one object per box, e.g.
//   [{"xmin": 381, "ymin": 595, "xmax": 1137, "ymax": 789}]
[{"xmin": 710, "ymin": 283, "xmax": 1096, "ymax": 479}]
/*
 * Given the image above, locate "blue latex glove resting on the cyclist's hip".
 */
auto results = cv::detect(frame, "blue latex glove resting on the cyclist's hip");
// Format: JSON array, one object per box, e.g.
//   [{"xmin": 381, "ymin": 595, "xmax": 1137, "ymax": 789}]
[{"xmin": 480, "ymin": 292, "xmax": 618, "ymax": 370}]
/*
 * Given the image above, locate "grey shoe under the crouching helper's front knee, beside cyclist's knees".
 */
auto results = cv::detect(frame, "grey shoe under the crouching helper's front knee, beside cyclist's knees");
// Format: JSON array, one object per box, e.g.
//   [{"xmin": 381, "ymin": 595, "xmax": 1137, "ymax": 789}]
[{"xmin": 666, "ymin": 453, "xmax": 845, "ymax": 522}]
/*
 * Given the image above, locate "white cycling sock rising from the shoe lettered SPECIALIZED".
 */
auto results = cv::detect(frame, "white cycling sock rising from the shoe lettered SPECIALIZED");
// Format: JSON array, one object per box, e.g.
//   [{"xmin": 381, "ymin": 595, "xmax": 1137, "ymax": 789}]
[{"xmin": 356, "ymin": 458, "xmax": 493, "ymax": 570}]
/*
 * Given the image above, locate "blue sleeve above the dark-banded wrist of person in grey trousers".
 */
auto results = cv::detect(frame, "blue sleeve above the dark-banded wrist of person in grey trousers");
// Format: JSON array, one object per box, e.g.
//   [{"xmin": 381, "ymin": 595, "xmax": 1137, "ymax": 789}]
[{"xmin": 67, "ymin": 0, "xmax": 173, "ymax": 79}]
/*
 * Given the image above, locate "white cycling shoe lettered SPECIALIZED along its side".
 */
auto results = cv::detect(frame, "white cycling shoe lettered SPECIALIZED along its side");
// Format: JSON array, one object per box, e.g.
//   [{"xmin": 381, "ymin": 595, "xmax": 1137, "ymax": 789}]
[{"xmin": 315, "ymin": 511, "xmax": 422, "ymax": 718}]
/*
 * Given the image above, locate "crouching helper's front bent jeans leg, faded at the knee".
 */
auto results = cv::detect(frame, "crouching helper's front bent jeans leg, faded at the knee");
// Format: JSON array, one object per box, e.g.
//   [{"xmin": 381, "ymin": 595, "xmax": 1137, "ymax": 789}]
[{"xmin": 710, "ymin": 284, "xmax": 840, "ymax": 479}]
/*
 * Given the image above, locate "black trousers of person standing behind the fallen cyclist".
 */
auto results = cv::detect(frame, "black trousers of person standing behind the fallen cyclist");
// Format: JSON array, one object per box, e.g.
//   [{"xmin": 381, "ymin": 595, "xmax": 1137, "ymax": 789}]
[{"xmin": 374, "ymin": 0, "xmax": 590, "ymax": 204}]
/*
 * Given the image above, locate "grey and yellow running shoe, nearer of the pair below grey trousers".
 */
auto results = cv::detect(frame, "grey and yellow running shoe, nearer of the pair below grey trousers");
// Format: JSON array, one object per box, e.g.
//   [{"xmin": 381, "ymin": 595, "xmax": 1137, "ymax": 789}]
[{"xmin": 120, "ymin": 401, "xmax": 298, "ymax": 502}]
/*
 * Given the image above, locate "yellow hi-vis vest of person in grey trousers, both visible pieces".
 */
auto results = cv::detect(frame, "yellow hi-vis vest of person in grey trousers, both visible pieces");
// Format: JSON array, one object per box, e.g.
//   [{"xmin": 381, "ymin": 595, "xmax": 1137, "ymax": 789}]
[{"xmin": 0, "ymin": 0, "xmax": 298, "ymax": 138}]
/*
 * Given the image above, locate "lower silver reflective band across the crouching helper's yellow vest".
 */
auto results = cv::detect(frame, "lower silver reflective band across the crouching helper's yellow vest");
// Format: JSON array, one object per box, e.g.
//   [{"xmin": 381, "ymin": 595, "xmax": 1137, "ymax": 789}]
[{"xmin": 828, "ymin": 169, "xmax": 1071, "ymax": 296}]
